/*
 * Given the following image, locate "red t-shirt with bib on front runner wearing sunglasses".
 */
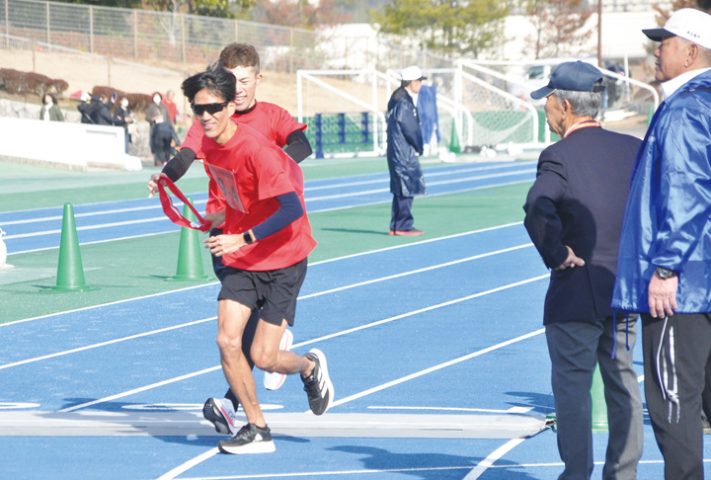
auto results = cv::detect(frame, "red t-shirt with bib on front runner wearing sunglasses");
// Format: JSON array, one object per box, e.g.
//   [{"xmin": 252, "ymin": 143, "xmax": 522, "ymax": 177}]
[{"xmin": 201, "ymin": 122, "xmax": 316, "ymax": 271}]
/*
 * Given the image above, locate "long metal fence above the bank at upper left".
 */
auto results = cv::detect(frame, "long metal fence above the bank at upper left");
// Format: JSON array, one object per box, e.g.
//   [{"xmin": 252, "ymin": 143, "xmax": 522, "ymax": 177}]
[{"xmin": 0, "ymin": 0, "xmax": 322, "ymax": 72}]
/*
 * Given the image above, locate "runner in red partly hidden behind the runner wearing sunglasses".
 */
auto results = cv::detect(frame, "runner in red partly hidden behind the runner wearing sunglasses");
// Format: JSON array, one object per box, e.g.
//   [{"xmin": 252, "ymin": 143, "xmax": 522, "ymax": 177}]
[{"xmin": 148, "ymin": 43, "xmax": 312, "ymax": 433}]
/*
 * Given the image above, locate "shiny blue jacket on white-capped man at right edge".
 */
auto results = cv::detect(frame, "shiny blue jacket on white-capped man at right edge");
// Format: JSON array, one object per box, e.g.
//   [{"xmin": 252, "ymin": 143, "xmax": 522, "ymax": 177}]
[{"xmin": 612, "ymin": 71, "xmax": 711, "ymax": 313}]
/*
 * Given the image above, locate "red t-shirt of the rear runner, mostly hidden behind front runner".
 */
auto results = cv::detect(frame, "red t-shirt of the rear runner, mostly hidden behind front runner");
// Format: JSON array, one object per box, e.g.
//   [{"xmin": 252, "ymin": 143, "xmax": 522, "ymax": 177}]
[{"xmin": 181, "ymin": 102, "xmax": 307, "ymax": 213}]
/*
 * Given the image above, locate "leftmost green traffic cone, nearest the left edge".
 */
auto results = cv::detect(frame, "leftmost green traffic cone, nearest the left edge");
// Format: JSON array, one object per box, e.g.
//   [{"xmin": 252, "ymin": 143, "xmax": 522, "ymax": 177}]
[{"xmin": 54, "ymin": 203, "xmax": 88, "ymax": 292}]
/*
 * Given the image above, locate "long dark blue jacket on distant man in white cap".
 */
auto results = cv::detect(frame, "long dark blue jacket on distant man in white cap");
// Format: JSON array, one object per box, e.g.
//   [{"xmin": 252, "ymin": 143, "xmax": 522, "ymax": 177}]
[{"xmin": 387, "ymin": 87, "xmax": 425, "ymax": 197}]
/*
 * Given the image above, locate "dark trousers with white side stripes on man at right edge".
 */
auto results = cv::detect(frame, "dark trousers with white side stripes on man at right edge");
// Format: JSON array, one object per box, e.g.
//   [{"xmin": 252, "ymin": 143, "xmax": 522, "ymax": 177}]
[{"xmin": 642, "ymin": 314, "xmax": 711, "ymax": 480}]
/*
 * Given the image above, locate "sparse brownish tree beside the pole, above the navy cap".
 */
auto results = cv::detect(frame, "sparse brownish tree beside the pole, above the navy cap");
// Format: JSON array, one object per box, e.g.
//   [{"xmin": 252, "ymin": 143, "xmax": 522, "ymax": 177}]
[{"xmin": 526, "ymin": 0, "xmax": 592, "ymax": 59}]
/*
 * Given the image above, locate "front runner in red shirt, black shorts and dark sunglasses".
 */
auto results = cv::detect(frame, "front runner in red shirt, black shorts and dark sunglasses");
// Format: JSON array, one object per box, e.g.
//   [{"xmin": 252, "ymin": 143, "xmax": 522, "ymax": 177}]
[{"xmin": 178, "ymin": 66, "xmax": 333, "ymax": 453}]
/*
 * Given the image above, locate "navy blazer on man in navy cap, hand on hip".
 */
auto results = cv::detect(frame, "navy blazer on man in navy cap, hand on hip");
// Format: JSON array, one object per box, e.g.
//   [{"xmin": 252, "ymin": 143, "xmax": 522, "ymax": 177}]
[{"xmin": 523, "ymin": 127, "xmax": 641, "ymax": 324}]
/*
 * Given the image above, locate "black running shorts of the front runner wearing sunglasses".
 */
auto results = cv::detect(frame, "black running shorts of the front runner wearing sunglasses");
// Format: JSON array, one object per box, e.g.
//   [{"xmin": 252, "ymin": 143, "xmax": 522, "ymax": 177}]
[{"xmin": 217, "ymin": 259, "xmax": 306, "ymax": 326}]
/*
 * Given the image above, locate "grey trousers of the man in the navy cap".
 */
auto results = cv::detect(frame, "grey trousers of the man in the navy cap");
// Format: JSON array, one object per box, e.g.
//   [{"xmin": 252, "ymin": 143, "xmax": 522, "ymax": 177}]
[{"xmin": 546, "ymin": 318, "xmax": 643, "ymax": 480}]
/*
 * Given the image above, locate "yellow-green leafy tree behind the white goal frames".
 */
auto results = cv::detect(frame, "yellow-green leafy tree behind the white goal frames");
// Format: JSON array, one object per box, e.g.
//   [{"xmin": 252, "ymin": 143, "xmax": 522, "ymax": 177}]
[{"xmin": 372, "ymin": 0, "xmax": 508, "ymax": 57}]
